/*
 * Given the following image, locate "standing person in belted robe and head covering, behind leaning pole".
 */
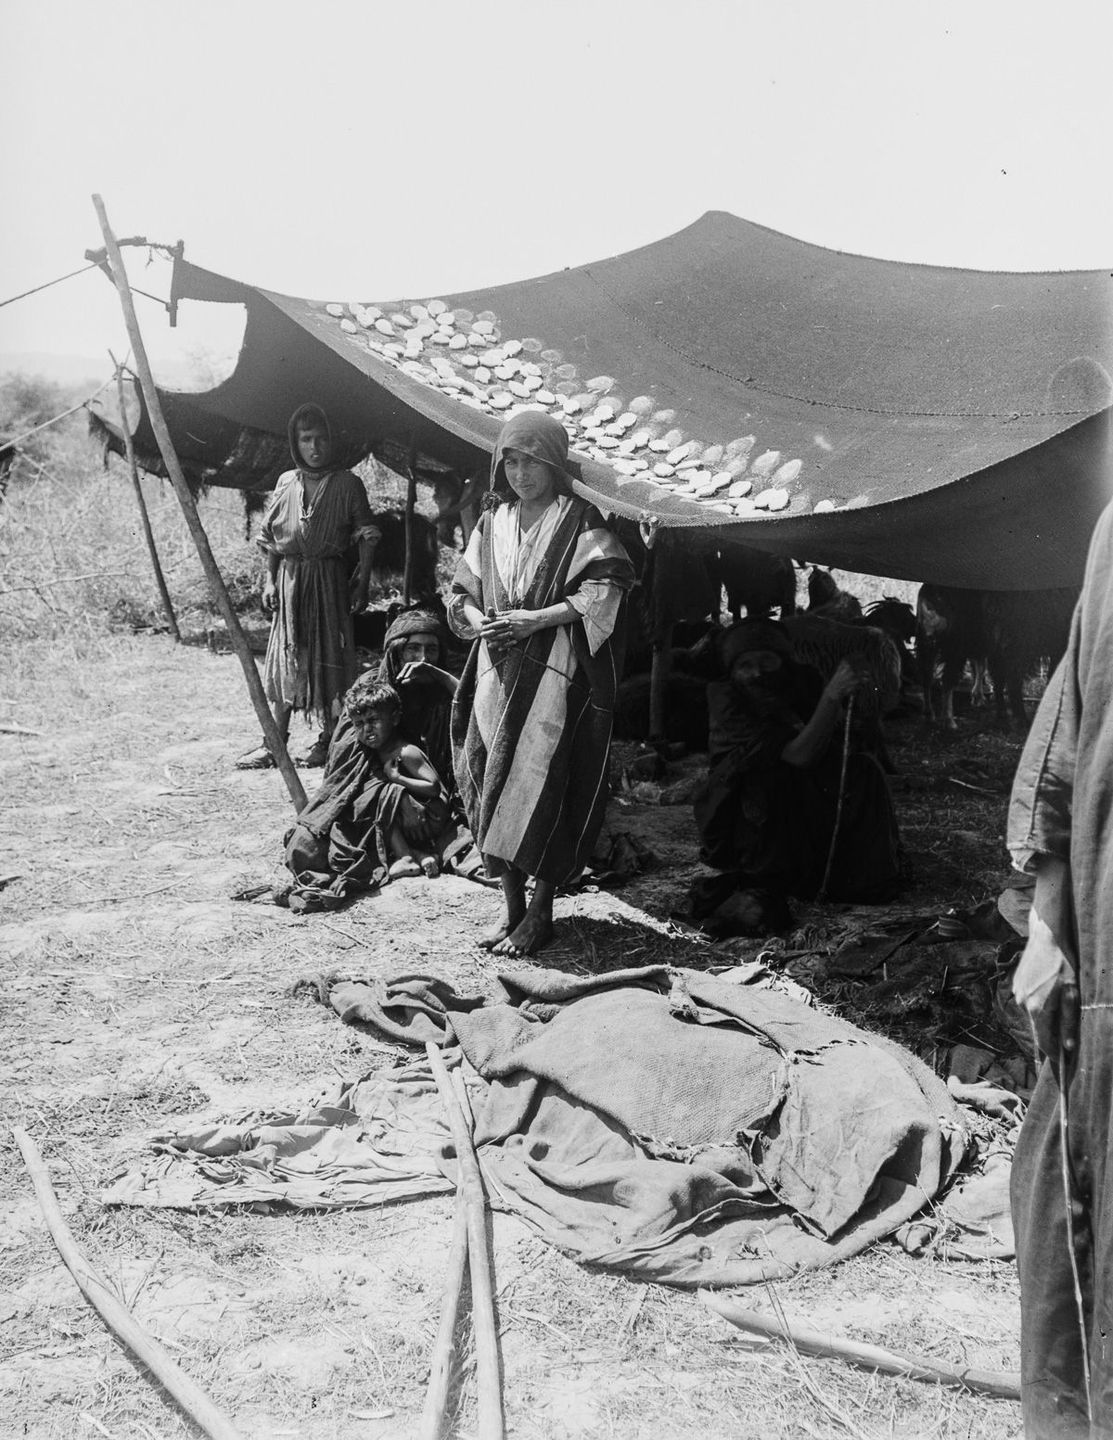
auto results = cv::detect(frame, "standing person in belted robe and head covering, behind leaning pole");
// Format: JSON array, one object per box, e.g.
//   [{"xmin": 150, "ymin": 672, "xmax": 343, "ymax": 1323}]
[{"xmin": 236, "ymin": 405, "xmax": 382, "ymax": 770}]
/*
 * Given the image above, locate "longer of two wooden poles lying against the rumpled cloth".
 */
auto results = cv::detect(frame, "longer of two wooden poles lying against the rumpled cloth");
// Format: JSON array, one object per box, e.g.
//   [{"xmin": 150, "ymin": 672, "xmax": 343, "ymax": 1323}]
[{"xmin": 425, "ymin": 1041, "xmax": 505, "ymax": 1440}]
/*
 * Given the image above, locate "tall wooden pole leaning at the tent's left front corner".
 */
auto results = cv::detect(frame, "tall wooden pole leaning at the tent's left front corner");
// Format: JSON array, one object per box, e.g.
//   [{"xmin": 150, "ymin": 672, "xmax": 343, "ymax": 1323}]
[{"xmin": 92, "ymin": 194, "xmax": 305, "ymax": 811}]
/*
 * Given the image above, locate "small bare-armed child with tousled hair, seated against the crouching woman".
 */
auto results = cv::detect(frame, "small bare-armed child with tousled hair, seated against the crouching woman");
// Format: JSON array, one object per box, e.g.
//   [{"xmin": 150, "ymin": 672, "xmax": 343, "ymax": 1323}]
[{"xmin": 351, "ymin": 680, "xmax": 445, "ymax": 880}]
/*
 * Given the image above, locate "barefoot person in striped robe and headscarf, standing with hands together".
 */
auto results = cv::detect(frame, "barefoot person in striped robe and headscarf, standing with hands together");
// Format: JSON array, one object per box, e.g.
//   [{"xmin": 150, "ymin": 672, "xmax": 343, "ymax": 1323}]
[{"xmin": 449, "ymin": 410, "xmax": 634, "ymax": 955}]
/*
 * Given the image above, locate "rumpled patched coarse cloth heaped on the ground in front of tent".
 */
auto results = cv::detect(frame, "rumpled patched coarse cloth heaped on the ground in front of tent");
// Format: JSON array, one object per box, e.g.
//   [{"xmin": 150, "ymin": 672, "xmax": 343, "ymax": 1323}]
[{"xmin": 105, "ymin": 966, "xmax": 966, "ymax": 1286}]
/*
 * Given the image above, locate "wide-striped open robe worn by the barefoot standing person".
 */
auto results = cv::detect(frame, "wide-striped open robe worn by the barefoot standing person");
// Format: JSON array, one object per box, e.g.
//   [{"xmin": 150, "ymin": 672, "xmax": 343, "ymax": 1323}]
[{"xmin": 449, "ymin": 497, "xmax": 634, "ymax": 884}]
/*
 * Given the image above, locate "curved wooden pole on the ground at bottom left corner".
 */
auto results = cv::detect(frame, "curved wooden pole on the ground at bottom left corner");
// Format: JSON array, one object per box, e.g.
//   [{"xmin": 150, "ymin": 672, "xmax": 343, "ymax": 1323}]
[{"xmin": 13, "ymin": 1129, "xmax": 242, "ymax": 1440}]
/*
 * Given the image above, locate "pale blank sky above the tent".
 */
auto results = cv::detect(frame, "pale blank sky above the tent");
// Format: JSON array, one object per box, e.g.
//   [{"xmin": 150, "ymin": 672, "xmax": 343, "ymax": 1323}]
[{"xmin": 0, "ymin": 0, "xmax": 1113, "ymax": 380}]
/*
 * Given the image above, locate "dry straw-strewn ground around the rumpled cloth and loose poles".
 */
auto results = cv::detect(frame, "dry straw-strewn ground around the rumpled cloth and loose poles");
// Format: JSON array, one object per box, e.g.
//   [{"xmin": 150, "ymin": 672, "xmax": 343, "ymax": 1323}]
[{"xmin": 0, "ymin": 638, "xmax": 1019, "ymax": 1440}]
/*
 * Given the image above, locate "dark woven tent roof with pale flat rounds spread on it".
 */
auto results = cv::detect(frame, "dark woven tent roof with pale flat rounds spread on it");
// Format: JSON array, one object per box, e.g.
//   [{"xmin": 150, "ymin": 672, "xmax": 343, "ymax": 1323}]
[{"xmin": 143, "ymin": 212, "xmax": 1113, "ymax": 589}]
